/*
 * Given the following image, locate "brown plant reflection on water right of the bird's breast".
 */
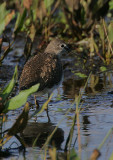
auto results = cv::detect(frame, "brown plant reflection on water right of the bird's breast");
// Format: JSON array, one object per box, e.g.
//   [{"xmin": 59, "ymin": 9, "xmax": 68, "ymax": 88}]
[{"xmin": 62, "ymin": 72, "xmax": 113, "ymax": 99}]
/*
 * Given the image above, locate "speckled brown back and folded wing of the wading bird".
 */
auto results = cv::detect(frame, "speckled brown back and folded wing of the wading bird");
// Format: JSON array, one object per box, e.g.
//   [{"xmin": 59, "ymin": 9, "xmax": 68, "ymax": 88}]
[{"xmin": 20, "ymin": 53, "xmax": 62, "ymax": 94}]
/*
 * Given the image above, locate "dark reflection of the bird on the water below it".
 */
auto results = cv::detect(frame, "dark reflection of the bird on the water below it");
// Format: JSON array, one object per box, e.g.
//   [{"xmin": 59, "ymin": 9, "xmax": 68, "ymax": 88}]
[{"xmin": 22, "ymin": 122, "xmax": 64, "ymax": 149}]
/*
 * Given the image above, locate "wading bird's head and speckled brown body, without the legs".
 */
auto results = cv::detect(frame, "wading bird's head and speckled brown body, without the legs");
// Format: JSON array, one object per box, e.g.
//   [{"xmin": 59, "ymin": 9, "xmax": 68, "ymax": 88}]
[{"xmin": 19, "ymin": 39, "xmax": 68, "ymax": 95}]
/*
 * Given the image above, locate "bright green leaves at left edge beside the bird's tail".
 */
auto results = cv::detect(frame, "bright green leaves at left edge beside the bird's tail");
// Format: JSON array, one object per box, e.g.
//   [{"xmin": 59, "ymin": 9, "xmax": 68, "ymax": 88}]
[{"xmin": 0, "ymin": 66, "xmax": 39, "ymax": 113}]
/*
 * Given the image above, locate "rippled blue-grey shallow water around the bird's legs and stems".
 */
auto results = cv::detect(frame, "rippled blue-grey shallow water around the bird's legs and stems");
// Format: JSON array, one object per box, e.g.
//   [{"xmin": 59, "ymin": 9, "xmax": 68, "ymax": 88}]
[{"xmin": 0, "ymin": 37, "xmax": 113, "ymax": 160}]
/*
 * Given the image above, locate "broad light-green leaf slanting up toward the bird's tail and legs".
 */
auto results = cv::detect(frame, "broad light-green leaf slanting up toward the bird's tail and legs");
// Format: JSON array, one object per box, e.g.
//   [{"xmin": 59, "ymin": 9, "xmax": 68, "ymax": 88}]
[{"xmin": 3, "ymin": 84, "xmax": 39, "ymax": 112}]
